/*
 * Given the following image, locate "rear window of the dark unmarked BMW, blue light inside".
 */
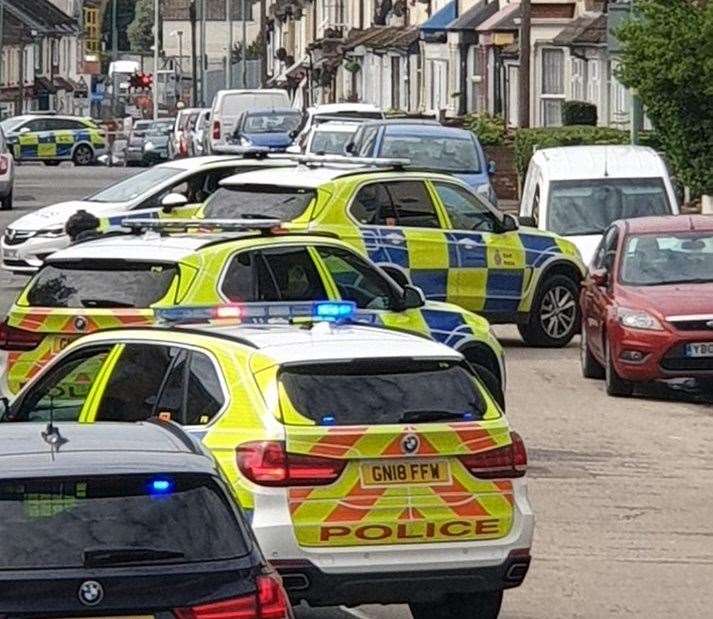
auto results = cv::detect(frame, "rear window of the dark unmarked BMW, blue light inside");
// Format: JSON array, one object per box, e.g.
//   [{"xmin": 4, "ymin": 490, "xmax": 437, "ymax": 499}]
[{"xmin": 0, "ymin": 474, "xmax": 248, "ymax": 570}]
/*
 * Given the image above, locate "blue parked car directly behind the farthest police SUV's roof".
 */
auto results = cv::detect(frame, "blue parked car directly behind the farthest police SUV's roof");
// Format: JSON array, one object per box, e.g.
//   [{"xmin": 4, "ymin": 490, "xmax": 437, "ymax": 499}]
[{"xmin": 346, "ymin": 119, "xmax": 497, "ymax": 205}]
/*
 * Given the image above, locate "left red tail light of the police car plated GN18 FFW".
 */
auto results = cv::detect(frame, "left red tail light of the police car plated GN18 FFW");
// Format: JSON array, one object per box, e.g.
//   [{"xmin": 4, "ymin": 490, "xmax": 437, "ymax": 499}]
[{"xmin": 236, "ymin": 441, "xmax": 347, "ymax": 487}]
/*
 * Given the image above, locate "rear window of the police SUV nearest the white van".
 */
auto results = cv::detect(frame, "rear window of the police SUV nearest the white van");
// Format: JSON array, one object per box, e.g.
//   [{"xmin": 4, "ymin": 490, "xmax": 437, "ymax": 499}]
[{"xmin": 203, "ymin": 185, "xmax": 315, "ymax": 221}]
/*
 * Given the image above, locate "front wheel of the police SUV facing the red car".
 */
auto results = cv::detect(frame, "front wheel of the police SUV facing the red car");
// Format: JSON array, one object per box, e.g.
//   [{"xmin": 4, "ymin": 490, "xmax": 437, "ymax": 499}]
[{"xmin": 517, "ymin": 275, "xmax": 580, "ymax": 348}]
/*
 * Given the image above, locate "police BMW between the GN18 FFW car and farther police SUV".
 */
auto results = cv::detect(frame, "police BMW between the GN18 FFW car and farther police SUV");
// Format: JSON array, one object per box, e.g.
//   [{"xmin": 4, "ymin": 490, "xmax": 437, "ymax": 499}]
[{"xmin": 0, "ymin": 220, "xmax": 505, "ymax": 405}]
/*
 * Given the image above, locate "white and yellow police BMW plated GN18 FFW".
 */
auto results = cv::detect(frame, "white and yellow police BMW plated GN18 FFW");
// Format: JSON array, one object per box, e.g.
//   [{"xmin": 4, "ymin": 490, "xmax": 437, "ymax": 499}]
[{"xmin": 5, "ymin": 302, "xmax": 534, "ymax": 619}]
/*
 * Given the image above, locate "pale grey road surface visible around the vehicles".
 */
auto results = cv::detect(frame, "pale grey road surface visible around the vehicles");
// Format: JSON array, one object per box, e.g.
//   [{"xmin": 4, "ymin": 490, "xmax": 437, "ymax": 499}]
[{"xmin": 0, "ymin": 165, "xmax": 713, "ymax": 619}]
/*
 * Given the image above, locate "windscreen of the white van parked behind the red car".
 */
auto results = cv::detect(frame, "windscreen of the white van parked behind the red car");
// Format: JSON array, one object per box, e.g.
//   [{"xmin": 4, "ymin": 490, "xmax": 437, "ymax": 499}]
[{"xmin": 547, "ymin": 178, "xmax": 671, "ymax": 236}]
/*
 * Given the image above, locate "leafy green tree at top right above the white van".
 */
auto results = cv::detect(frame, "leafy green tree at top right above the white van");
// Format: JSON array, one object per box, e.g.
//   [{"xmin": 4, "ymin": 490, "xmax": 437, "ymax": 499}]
[{"xmin": 617, "ymin": 0, "xmax": 713, "ymax": 199}]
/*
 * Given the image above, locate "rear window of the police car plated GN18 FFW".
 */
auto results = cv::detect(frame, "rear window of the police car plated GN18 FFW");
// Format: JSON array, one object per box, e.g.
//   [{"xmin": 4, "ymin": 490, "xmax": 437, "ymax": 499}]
[{"xmin": 280, "ymin": 359, "xmax": 485, "ymax": 425}]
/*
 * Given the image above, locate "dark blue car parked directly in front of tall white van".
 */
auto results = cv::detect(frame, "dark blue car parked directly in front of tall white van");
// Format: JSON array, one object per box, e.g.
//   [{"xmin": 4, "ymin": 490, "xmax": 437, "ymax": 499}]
[{"xmin": 231, "ymin": 108, "xmax": 302, "ymax": 152}]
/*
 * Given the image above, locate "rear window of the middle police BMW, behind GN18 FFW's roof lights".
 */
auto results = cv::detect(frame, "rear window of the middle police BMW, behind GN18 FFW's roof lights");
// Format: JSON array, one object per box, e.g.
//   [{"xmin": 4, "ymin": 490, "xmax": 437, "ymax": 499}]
[{"xmin": 27, "ymin": 260, "xmax": 178, "ymax": 308}]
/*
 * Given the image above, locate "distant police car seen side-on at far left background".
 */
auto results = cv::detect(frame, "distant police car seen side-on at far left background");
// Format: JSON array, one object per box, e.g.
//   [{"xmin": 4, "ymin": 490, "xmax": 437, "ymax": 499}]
[{"xmin": 2, "ymin": 114, "xmax": 107, "ymax": 166}]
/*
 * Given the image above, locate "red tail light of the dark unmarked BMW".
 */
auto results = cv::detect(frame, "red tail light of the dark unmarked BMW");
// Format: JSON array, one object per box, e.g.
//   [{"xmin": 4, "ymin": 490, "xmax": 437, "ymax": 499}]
[{"xmin": 174, "ymin": 576, "xmax": 290, "ymax": 619}]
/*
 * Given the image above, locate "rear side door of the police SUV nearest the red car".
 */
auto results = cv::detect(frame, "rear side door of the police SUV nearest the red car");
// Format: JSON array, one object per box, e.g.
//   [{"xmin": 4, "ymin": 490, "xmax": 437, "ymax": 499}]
[{"xmin": 351, "ymin": 180, "xmax": 449, "ymax": 301}]
